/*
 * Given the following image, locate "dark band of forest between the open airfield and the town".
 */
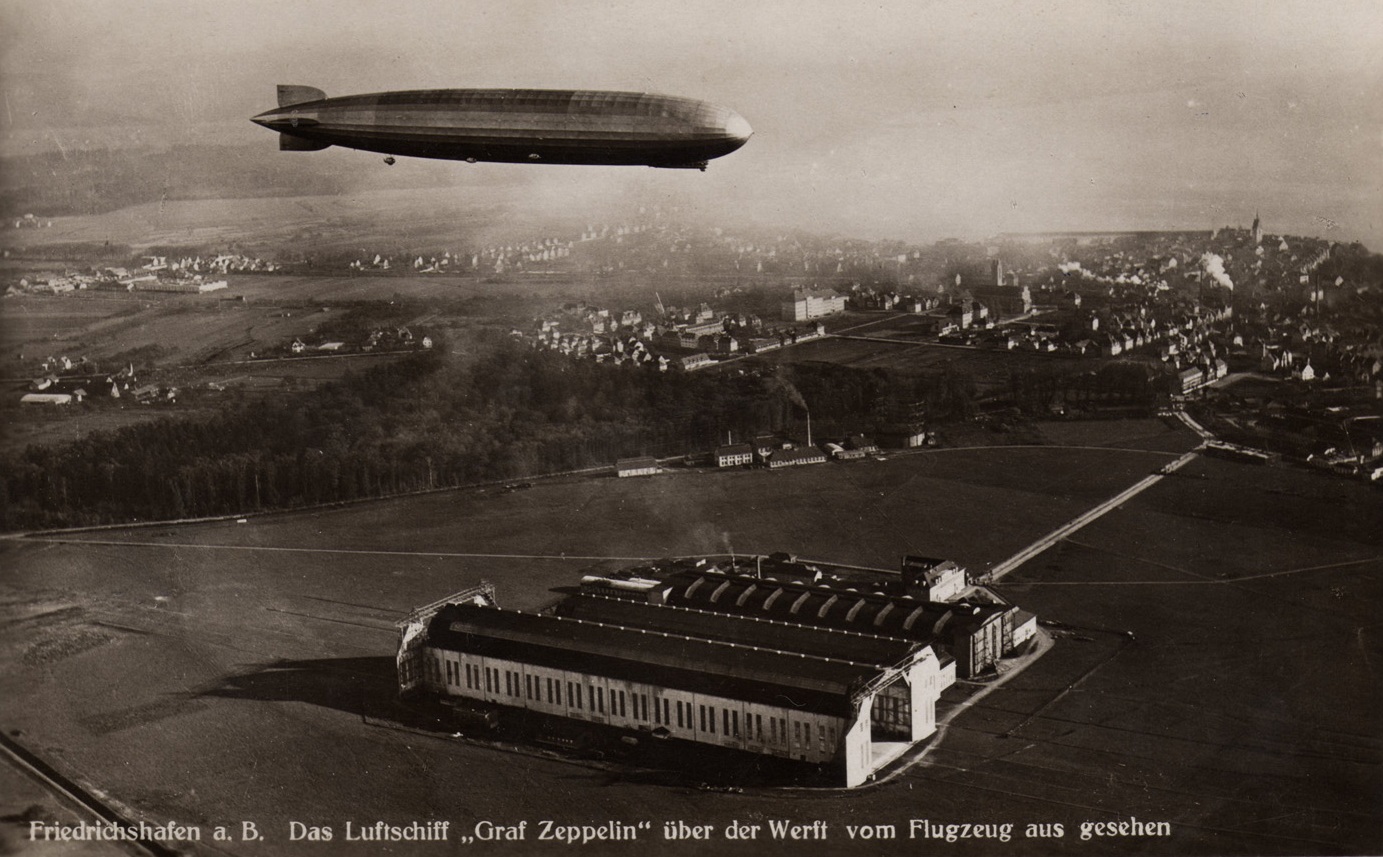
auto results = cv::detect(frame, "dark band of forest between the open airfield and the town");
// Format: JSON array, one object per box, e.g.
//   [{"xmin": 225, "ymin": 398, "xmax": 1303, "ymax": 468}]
[{"xmin": 0, "ymin": 333, "xmax": 995, "ymax": 529}]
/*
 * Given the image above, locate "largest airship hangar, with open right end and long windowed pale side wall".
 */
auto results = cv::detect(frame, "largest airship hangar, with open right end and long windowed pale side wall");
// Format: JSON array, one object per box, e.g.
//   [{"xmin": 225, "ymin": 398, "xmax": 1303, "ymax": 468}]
[{"xmin": 398, "ymin": 581, "xmax": 954, "ymax": 787}]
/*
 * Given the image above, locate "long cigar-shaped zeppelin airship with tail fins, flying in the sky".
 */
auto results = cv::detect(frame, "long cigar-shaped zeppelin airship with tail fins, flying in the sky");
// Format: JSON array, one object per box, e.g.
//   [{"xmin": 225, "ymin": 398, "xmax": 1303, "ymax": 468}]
[{"xmin": 252, "ymin": 86, "xmax": 754, "ymax": 170}]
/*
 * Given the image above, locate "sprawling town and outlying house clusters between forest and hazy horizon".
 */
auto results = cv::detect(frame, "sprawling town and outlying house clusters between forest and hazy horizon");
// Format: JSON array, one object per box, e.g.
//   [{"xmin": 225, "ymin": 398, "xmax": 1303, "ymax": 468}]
[{"xmin": 7, "ymin": 209, "xmax": 1383, "ymax": 489}]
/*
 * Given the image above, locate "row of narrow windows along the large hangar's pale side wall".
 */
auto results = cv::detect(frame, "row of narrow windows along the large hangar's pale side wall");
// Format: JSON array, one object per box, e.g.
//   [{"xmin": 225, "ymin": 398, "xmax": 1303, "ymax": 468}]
[{"xmin": 437, "ymin": 659, "xmax": 835, "ymax": 753}]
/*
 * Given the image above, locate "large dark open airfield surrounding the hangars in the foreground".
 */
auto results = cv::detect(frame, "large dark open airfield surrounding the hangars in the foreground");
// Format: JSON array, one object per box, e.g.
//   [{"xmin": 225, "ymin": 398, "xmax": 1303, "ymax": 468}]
[{"xmin": 0, "ymin": 420, "xmax": 1383, "ymax": 854}]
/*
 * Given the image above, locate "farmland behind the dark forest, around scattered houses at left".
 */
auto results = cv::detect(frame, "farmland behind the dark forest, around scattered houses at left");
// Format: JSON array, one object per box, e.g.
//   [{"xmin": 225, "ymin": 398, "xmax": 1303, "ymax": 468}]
[{"xmin": 0, "ymin": 275, "xmax": 522, "ymax": 451}]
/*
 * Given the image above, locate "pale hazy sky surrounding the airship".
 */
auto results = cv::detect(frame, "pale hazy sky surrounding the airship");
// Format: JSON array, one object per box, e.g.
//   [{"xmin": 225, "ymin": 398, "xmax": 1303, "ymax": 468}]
[{"xmin": 0, "ymin": 0, "xmax": 1383, "ymax": 244}]
